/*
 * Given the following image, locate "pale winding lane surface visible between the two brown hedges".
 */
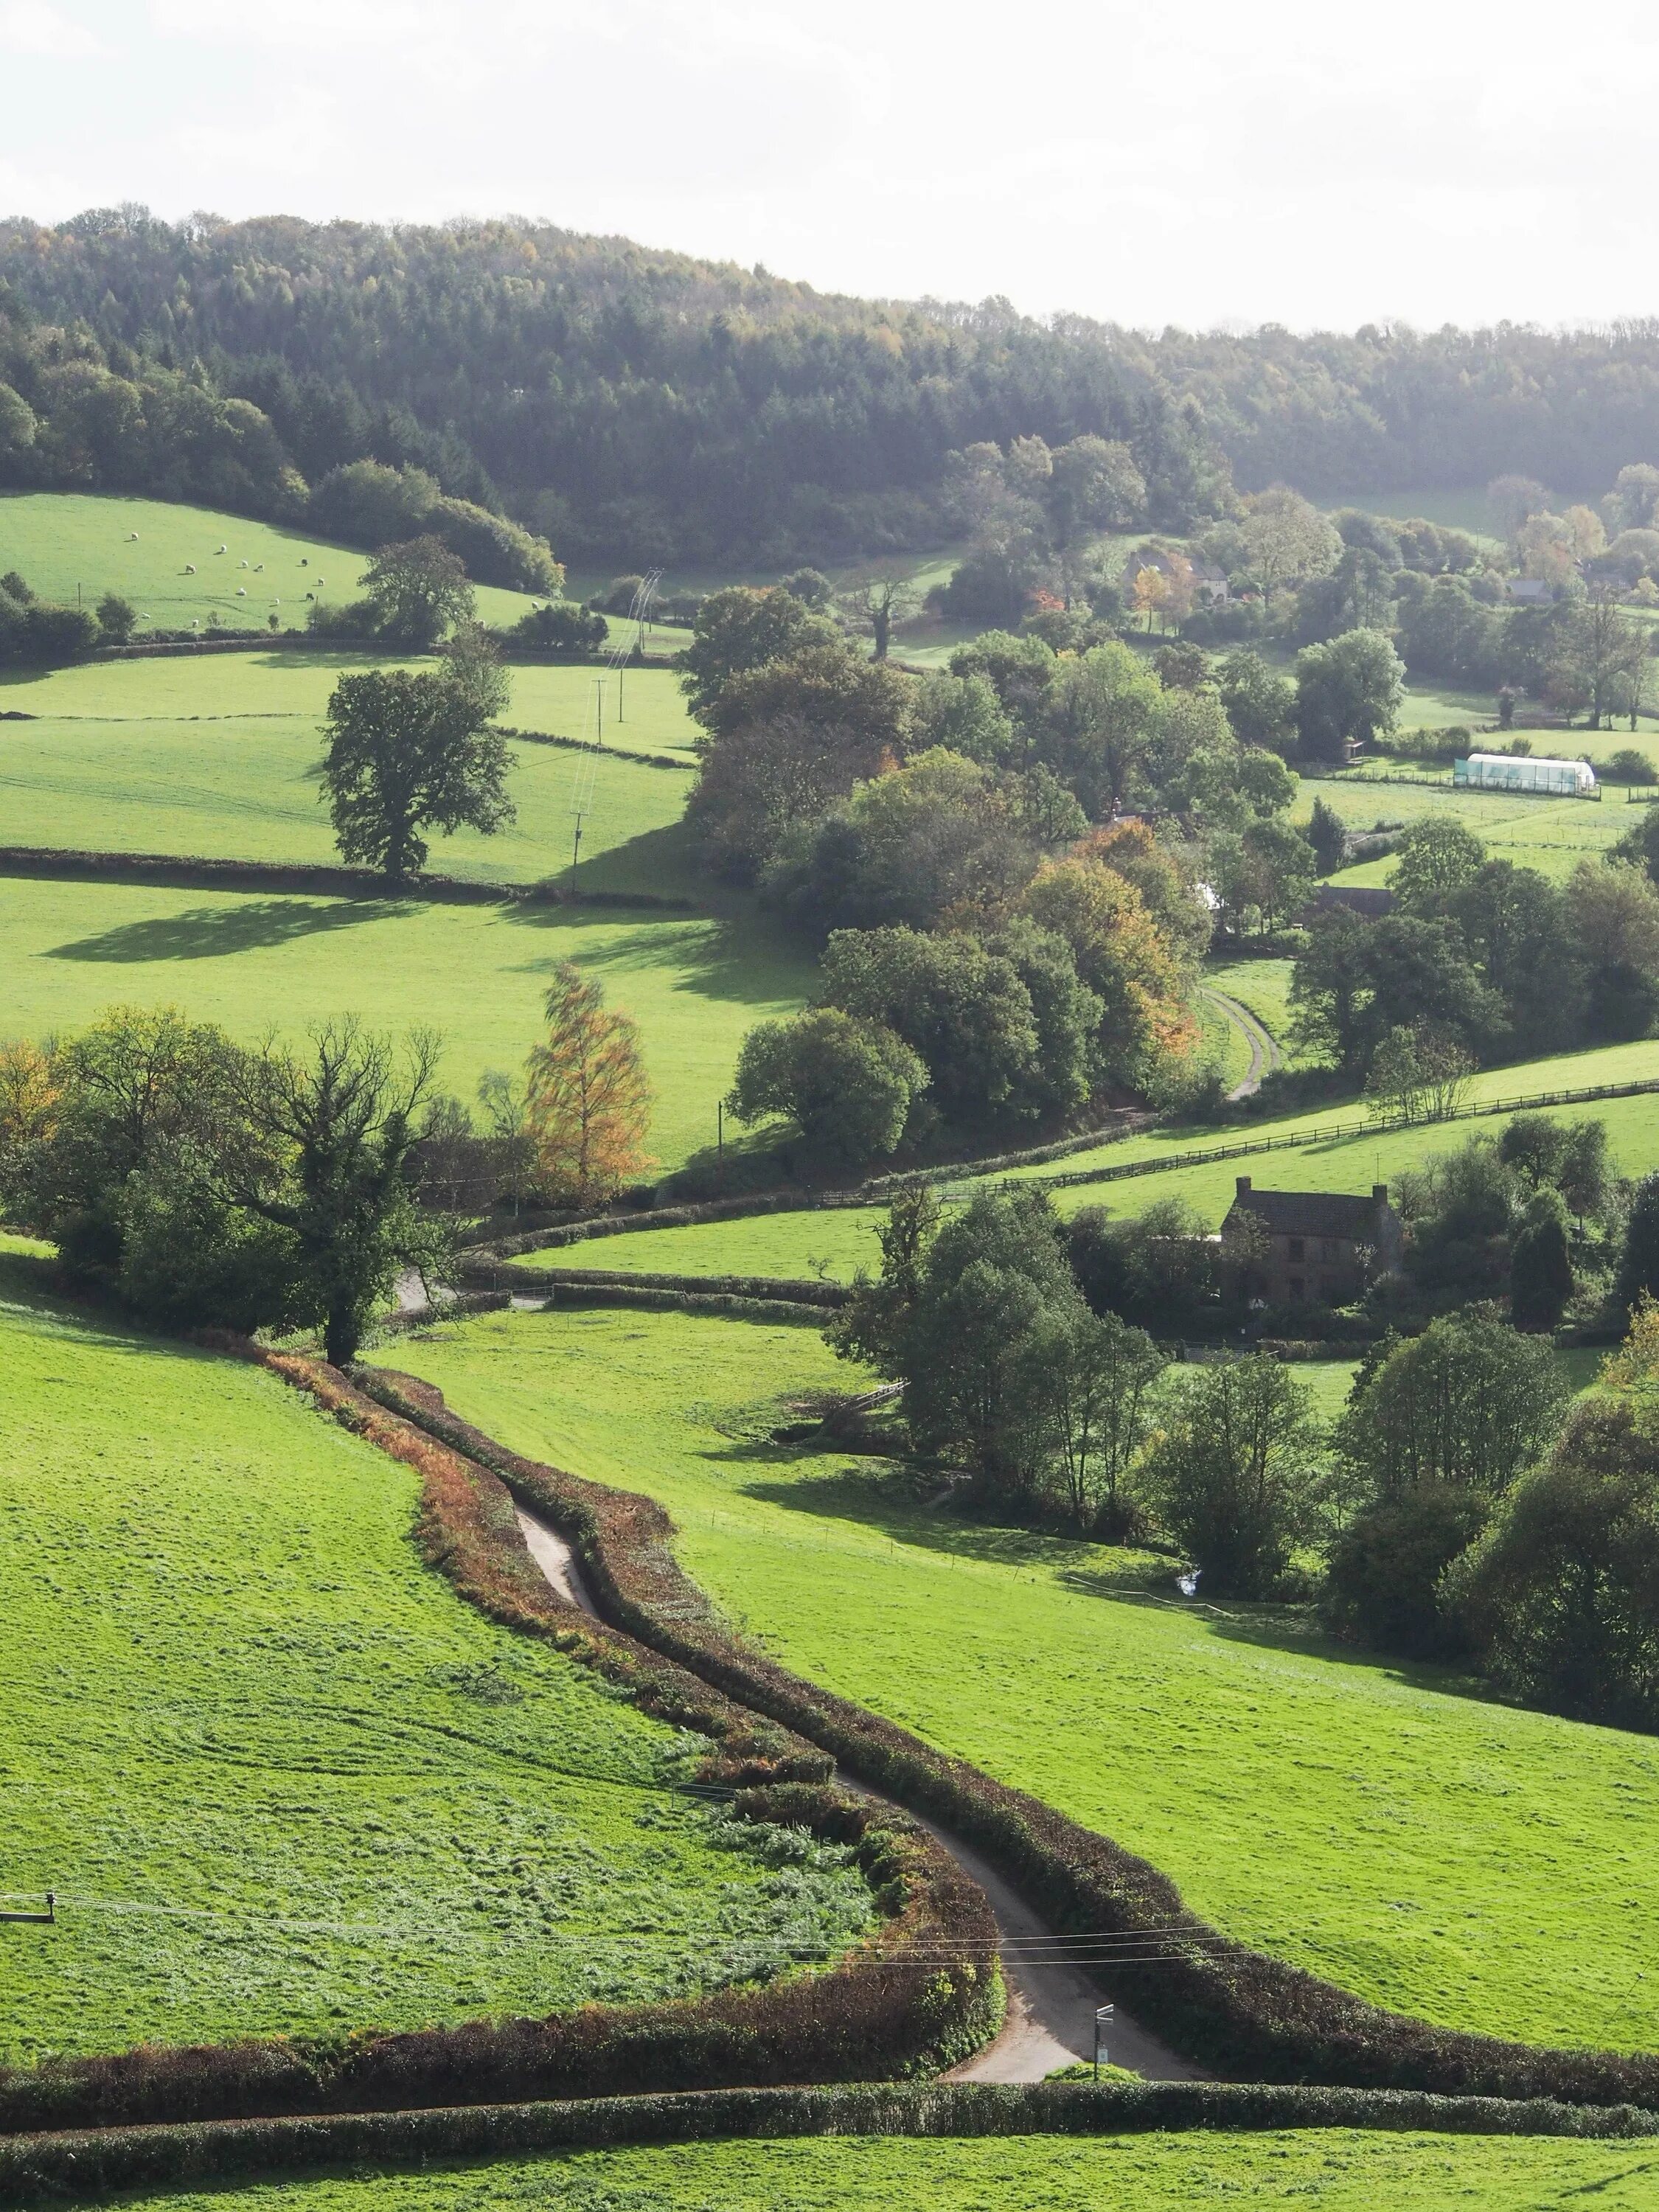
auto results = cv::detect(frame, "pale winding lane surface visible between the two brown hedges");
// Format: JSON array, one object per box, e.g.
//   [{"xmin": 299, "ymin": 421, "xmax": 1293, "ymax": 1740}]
[{"xmin": 515, "ymin": 1506, "xmax": 1203, "ymax": 2081}]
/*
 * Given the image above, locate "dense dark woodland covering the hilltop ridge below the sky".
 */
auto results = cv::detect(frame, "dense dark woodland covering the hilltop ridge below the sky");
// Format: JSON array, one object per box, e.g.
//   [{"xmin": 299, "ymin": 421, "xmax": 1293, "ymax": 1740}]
[{"xmin": 0, "ymin": 208, "xmax": 1659, "ymax": 562}]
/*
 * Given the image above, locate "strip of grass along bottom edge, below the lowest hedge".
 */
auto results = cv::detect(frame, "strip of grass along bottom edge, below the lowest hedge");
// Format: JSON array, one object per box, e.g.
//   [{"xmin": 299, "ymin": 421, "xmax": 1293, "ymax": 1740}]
[{"xmin": 111, "ymin": 2128, "xmax": 1659, "ymax": 2212}]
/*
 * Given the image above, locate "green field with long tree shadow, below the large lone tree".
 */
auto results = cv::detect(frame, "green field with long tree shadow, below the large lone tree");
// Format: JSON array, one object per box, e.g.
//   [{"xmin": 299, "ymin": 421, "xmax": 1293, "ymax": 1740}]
[{"xmin": 0, "ymin": 872, "xmax": 812, "ymax": 1166}]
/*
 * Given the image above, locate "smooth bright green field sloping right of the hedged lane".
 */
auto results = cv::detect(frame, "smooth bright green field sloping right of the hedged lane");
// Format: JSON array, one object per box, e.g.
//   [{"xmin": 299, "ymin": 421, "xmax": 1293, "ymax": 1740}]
[{"xmin": 389, "ymin": 1310, "xmax": 1659, "ymax": 2048}]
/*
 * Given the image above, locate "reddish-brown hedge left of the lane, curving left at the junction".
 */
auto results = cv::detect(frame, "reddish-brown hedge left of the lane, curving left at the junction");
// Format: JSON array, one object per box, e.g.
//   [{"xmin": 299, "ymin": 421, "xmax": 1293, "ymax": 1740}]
[{"xmin": 0, "ymin": 1336, "xmax": 1002, "ymax": 2141}]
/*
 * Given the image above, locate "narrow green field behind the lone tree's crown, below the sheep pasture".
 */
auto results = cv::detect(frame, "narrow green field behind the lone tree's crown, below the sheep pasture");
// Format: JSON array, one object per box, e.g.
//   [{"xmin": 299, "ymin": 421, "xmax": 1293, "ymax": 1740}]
[{"xmin": 0, "ymin": 646, "xmax": 697, "ymax": 765}]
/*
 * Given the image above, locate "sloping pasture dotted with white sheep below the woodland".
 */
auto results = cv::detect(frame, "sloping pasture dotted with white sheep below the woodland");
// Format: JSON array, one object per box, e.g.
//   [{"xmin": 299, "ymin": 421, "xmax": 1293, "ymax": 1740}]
[{"xmin": 0, "ymin": 491, "xmax": 553, "ymax": 637}]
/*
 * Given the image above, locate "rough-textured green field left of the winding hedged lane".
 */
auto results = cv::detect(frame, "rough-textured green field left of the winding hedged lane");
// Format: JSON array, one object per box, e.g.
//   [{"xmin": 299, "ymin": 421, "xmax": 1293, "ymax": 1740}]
[{"xmin": 0, "ymin": 1245, "xmax": 867, "ymax": 2059}]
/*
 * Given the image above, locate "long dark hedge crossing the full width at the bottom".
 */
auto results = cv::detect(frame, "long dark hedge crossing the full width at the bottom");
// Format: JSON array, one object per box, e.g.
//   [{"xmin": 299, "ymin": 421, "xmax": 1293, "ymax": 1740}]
[{"xmin": 0, "ymin": 2081, "xmax": 1659, "ymax": 2205}]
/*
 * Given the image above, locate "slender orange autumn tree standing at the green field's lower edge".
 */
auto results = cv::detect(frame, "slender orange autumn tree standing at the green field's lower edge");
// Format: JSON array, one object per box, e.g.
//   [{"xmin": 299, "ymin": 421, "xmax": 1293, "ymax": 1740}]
[{"xmin": 526, "ymin": 960, "xmax": 650, "ymax": 1206}]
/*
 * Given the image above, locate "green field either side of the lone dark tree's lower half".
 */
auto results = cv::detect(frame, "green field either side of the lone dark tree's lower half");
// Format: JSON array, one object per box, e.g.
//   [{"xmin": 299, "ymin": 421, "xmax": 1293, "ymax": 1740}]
[{"xmin": 0, "ymin": 714, "xmax": 708, "ymax": 902}]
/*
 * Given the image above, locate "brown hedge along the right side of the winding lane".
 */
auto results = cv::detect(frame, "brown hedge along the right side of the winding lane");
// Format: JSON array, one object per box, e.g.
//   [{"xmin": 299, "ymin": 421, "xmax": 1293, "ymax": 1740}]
[{"xmin": 365, "ymin": 1369, "xmax": 1659, "ymax": 2108}]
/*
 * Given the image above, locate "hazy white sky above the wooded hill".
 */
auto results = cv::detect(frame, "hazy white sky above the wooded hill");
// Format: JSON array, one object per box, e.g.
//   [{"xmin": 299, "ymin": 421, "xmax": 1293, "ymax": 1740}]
[{"xmin": 0, "ymin": 0, "xmax": 1659, "ymax": 327}]
